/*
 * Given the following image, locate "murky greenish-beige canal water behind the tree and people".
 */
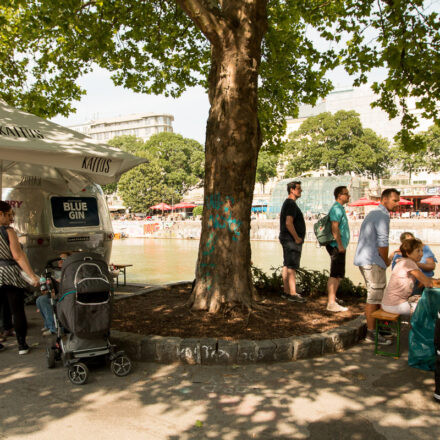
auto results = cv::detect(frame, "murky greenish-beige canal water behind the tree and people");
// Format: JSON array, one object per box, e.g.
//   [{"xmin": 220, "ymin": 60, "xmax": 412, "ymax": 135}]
[{"xmin": 111, "ymin": 238, "xmax": 440, "ymax": 284}]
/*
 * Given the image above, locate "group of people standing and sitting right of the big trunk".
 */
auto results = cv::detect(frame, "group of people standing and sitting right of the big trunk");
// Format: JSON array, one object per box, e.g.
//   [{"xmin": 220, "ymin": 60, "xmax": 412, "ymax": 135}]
[{"xmin": 279, "ymin": 181, "xmax": 439, "ymax": 345}]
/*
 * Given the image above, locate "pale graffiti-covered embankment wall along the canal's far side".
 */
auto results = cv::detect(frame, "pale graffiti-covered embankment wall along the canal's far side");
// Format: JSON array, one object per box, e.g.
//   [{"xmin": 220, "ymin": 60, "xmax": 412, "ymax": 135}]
[{"xmin": 112, "ymin": 219, "xmax": 440, "ymax": 244}]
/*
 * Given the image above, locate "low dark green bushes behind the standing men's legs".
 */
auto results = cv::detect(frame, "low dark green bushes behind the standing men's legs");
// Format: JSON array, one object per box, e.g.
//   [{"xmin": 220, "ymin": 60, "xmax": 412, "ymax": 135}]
[{"xmin": 251, "ymin": 266, "xmax": 367, "ymax": 298}]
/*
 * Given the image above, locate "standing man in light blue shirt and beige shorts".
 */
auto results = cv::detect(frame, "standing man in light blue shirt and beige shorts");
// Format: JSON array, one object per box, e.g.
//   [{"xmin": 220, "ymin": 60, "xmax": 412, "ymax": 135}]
[{"xmin": 354, "ymin": 188, "xmax": 400, "ymax": 345}]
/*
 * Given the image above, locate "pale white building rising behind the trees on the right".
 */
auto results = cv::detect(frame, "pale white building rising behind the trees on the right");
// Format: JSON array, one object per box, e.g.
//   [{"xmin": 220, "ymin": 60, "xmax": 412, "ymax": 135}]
[{"xmin": 286, "ymin": 85, "xmax": 433, "ymax": 141}]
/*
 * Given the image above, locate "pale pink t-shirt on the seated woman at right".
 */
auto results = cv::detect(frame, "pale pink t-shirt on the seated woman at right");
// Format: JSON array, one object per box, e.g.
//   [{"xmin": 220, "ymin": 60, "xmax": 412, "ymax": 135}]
[{"xmin": 382, "ymin": 258, "xmax": 420, "ymax": 306}]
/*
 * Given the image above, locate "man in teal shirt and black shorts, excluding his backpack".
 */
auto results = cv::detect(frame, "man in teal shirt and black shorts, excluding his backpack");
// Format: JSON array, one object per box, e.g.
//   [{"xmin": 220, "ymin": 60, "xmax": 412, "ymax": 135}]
[{"xmin": 326, "ymin": 186, "xmax": 350, "ymax": 312}]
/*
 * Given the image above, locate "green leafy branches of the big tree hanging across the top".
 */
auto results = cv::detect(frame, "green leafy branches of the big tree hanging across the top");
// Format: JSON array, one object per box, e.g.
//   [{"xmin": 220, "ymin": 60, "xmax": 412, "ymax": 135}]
[{"xmin": 0, "ymin": 0, "xmax": 440, "ymax": 150}]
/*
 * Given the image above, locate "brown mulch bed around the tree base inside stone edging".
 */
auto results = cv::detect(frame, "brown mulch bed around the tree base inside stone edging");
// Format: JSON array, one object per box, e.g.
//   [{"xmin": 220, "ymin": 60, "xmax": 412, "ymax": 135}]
[{"xmin": 112, "ymin": 285, "xmax": 364, "ymax": 340}]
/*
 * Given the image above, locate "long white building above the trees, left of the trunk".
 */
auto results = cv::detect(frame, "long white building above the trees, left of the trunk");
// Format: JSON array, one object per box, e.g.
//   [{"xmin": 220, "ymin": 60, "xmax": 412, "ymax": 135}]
[{"xmin": 69, "ymin": 113, "xmax": 174, "ymax": 142}]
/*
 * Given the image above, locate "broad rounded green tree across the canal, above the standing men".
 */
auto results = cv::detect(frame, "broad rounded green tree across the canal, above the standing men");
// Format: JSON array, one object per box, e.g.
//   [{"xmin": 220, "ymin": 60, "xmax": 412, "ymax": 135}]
[{"xmin": 285, "ymin": 110, "xmax": 389, "ymax": 177}]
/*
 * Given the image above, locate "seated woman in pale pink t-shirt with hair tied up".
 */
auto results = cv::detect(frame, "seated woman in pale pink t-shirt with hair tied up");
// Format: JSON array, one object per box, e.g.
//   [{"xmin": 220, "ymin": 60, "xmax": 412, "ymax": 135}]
[{"xmin": 382, "ymin": 238, "xmax": 434, "ymax": 315}]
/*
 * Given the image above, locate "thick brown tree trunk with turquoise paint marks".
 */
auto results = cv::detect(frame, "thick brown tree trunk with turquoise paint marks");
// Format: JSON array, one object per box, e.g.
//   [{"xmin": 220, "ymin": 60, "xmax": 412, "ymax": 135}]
[{"xmin": 179, "ymin": 0, "xmax": 267, "ymax": 313}]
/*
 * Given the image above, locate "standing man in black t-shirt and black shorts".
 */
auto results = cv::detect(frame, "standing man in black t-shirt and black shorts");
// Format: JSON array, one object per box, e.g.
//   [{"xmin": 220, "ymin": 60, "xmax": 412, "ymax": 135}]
[{"xmin": 279, "ymin": 182, "xmax": 306, "ymax": 302}]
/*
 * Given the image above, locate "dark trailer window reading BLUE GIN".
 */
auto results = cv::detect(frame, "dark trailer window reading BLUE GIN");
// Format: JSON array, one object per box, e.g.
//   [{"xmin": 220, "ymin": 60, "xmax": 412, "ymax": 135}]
[{"xmin": 50, "ymin": 197, "xmax": 99, "ymax": 228}]
